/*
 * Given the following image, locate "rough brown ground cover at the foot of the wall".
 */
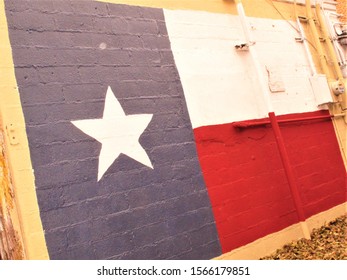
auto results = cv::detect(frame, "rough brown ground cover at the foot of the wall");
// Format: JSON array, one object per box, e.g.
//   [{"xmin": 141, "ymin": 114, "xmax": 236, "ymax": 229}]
[{"xmin": 261, "ymin": 215, "xmax": 347, "ymax": 260}]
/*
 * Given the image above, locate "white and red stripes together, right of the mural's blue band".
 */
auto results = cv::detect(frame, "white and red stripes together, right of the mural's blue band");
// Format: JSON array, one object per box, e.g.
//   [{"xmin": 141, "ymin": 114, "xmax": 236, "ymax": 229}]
[{"xmin": 165, "ymin": 10, "xmax": 346, "ymax": 252}]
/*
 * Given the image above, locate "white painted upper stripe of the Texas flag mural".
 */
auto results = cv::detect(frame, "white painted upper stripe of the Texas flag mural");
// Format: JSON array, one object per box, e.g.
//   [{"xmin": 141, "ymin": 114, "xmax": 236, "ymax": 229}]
[{"xmin": 164, "ymin": 10, "xmax": 317, "ymax": 127}]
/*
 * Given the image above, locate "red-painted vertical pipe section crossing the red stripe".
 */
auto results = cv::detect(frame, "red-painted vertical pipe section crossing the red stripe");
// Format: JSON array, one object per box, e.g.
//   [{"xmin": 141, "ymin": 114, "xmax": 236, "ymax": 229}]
[{"xmin": 269, "ymin": 112, "xmax": 305, "ymax": 222}]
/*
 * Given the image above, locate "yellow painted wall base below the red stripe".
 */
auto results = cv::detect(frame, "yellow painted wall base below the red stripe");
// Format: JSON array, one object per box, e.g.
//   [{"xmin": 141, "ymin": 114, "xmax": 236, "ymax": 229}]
[{"xmin": 215, "ymin": 202, "xmax": 347, "ymax": 260}]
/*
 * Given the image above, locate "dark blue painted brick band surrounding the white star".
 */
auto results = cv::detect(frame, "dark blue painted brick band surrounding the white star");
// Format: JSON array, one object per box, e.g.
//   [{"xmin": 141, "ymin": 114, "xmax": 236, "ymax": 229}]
[{"xmin": 6, "ymin": 1, "xmax": 221, "ymax": 259}]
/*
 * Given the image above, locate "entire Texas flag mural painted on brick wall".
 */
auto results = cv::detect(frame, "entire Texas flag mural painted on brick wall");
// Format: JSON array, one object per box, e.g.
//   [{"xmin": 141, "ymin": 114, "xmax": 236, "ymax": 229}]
[{"xmin": 5, "ymin": 0, "xmax": 346, "ymax": 259}]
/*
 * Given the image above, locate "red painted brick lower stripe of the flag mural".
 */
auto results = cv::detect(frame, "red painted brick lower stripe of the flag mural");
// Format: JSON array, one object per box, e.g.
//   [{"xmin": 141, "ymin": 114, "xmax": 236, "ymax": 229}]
[{"xmin": 194, "ymin": 112, "xmax": 346, "ymax": 252}]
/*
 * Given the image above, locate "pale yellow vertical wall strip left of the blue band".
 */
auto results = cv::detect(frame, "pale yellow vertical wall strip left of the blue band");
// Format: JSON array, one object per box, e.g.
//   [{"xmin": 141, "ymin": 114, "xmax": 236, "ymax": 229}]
[{"xmin": 0, "ymin": 0, "xmax": 49, "ymax": 259}]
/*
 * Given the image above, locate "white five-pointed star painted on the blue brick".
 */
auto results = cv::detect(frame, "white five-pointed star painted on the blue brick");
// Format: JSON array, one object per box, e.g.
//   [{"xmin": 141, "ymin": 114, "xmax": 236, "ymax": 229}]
[{"xmin": 71, "ymin": 87, "xmax": 153, "ymax": 181}]
